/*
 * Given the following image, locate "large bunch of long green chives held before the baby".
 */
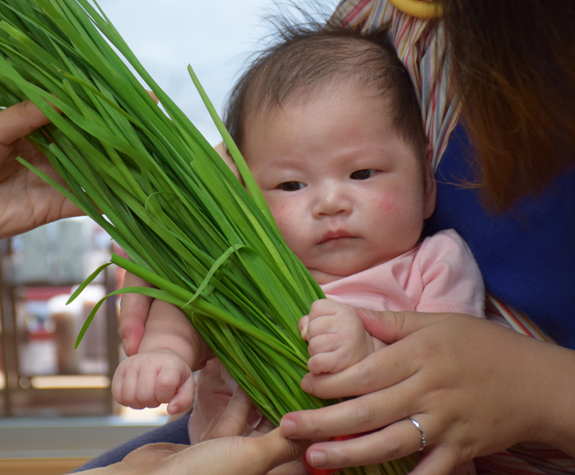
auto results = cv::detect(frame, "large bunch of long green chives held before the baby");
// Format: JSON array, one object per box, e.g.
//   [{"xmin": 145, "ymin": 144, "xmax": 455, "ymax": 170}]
[{"xmin": 0, "ymin": 0, "xmax": 413, "ymax": 475}]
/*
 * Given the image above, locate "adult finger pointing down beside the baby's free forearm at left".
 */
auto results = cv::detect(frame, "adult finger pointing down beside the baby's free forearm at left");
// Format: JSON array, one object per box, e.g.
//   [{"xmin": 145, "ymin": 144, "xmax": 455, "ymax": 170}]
[{"xmin": 119, "ymin": 272, "xmax": 154, "ymax": 356}]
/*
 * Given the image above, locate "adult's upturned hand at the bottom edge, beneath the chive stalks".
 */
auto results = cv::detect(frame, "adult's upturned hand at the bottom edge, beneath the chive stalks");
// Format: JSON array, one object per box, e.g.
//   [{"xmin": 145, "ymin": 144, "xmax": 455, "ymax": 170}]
[{"xmin": 82, "ymin": 390, "xmax": 308, "ymax": 475}]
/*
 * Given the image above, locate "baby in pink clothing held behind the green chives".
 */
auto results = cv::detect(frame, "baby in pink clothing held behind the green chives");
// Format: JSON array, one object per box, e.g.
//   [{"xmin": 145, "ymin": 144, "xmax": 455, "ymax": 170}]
[{"xmin": 113, "ymin": 22, "xmax": 484, "ymax": 444}]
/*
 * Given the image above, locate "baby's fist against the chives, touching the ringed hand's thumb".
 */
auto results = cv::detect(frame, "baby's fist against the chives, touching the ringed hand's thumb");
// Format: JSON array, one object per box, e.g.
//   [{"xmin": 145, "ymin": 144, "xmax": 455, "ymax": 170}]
[{"xmin": 299, "ymin": 299, "xmax": 374, "ymax": 374}]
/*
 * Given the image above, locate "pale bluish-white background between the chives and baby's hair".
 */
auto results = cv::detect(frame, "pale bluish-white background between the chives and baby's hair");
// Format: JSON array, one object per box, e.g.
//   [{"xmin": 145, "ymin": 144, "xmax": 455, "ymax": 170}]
[{"xmin": 94, "ymin": 0, "xmax": 337, "ymax": 144}]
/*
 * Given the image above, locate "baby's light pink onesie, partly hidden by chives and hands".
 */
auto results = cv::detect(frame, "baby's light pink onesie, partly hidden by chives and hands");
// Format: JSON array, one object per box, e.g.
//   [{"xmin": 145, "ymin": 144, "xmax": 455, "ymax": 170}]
[{"xmin": 189, "ymin": 230, "xmax": 485, "ymax": 445}]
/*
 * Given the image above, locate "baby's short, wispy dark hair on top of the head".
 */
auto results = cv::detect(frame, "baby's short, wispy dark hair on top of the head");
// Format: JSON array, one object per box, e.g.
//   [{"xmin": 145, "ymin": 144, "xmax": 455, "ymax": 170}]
[{"xmin": 224, "ymin": 21, "xmax": 426, "ymax": 157}]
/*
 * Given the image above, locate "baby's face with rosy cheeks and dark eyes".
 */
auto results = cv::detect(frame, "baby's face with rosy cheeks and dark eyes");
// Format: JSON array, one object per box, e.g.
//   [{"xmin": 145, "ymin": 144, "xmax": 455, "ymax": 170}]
[{"xmin": 243, "ymin": 83, "xmax": 435, "ymax": 284}]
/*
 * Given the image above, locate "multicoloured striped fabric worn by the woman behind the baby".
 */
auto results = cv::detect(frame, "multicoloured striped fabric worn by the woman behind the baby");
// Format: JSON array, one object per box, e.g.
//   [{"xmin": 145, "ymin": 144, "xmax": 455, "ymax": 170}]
[{"xmin": 331, "ymin": 0, "xmax": 575, "ymax": 475}]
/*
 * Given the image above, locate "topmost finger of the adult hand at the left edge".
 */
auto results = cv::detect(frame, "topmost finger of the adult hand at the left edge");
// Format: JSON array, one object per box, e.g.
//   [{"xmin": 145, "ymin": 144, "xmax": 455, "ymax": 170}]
[{"xmin": 0, "ymin": 99, "xmax": 50, "ymax": 146}]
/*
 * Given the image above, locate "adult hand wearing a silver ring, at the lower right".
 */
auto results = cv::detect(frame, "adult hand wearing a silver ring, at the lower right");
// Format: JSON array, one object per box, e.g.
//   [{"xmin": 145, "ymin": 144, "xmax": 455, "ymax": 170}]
[{"xmin": 280, "ymin": 311, "xmax": 575, "ymax": 475}]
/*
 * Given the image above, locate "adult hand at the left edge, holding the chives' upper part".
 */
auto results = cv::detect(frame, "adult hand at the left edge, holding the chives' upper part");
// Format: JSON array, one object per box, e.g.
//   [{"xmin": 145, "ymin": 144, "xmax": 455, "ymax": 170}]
[{"xmin": 0, "ymin": 101, "xmax": 82, "ymax": 238}]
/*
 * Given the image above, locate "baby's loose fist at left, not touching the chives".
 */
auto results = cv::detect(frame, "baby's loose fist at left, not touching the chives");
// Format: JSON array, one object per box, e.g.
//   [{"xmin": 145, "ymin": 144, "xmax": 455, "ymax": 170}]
[{"xmin": 112, "ymin": 350, "xmax": 194, "ymax": 414}]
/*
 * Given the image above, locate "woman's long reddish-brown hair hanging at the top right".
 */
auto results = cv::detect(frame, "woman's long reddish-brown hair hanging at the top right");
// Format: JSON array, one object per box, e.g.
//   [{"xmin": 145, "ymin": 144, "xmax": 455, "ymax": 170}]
[{"xmin": 439, "ymin": 0, "xmax": 575, "ymax": 211}]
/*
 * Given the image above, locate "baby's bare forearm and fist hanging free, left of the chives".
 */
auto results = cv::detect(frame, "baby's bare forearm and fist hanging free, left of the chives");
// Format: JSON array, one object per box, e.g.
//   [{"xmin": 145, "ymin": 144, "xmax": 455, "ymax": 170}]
[{"xmin": 112, "ymin": 300, "xmax": 198, "ymax": 414}]
